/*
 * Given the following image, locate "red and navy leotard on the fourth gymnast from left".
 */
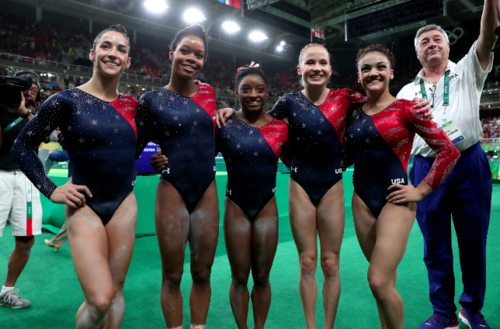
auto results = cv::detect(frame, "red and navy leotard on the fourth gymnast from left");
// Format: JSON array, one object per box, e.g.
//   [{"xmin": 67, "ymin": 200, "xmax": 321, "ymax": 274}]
[{"xmin": 269, "ymin": 89, "xmax": 365, "ymax": 206}]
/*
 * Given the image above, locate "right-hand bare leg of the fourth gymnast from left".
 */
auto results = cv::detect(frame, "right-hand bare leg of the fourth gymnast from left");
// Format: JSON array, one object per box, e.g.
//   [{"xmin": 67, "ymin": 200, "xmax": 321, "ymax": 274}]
[{"xmin": 317, "ymin": 181, "xmax": 345, "ymax": 329}]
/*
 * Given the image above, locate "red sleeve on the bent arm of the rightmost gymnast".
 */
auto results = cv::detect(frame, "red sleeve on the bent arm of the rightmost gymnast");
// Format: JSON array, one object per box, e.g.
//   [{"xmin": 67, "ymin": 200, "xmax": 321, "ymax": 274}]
[{"xmin": 406, "ymin": 104, "xmax": 460, "ymax": 190}]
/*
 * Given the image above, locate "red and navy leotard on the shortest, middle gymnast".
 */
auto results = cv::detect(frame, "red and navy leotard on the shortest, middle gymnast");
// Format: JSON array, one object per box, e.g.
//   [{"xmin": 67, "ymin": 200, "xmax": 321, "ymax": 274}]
[{"xmin": 216, "ymin": 115, "xmax": 288, "ymax": 220}]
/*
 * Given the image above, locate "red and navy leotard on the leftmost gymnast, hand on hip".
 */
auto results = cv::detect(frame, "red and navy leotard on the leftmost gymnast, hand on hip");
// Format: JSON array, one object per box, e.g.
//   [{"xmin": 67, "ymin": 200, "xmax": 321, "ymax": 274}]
[{"xmin": 11, "ymin": 88, "xmax": 137, "ymax": 225}]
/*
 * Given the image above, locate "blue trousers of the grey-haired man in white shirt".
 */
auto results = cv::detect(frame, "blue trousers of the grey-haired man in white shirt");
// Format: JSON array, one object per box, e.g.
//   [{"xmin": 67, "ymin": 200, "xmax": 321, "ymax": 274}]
[{"xmin": 410, "ymin": 143, "xmax": 492, "ymax": 315}]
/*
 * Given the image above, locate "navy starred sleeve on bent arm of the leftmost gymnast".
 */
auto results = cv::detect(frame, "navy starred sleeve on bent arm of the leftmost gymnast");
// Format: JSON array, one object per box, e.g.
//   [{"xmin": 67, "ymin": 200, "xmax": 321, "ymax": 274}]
[{"xmin": 11, "ymin": 94, "xmax": 66, "ymax": 199}]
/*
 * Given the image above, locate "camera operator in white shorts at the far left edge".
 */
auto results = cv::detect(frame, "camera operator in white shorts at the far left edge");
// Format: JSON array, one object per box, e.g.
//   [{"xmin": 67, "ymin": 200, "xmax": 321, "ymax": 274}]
[{"xmin": 0, "ymin": 71, "xmax": 42, "ymax": 309}]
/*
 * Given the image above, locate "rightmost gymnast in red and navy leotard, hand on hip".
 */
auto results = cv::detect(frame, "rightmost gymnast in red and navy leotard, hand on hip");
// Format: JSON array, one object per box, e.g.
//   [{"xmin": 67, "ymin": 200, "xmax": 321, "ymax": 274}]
[{"xmin": 342, "ymin": 44, "xmax": 460, "ymax": 329}]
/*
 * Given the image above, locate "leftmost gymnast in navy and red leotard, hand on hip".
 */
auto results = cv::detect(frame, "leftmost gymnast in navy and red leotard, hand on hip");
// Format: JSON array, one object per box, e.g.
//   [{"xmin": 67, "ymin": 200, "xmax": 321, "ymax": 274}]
[{"xmin": 12, "ymin": 25, "xmax": 137, "ymax": 329}]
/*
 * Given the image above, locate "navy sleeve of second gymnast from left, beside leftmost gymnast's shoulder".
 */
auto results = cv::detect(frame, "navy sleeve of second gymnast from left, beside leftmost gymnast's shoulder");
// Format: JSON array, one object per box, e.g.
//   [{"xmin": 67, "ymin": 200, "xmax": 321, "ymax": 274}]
[{"xmin": 135, "ymin": 93, "xmax": 156, "ymax": 159}]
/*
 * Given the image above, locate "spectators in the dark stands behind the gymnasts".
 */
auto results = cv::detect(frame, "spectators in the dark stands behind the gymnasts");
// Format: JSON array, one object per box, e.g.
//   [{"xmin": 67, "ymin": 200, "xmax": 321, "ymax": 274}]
[{"xmin": 0, "ymin": 13, "xmax": 500, "ymax": 116}]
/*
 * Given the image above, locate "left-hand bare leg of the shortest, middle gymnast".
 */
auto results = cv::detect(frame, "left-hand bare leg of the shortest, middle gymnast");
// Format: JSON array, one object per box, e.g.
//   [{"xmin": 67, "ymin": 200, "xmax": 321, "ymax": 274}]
[{"xmin": 224, "ymin": 198, "xmax": 252, "ymax": 329}]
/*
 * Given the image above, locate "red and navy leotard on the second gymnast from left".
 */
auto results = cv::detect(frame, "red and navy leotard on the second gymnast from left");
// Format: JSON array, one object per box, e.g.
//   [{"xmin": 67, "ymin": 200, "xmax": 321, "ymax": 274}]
[{"xmin": 136, "ymin": 86, "xmax": 217, "ymax": 213}]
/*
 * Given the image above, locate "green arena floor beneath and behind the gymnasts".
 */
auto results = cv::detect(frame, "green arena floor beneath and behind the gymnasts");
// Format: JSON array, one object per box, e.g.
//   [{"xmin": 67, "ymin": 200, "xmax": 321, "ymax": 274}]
[{"xmin": 0, "ymin": 184, "xmax": 500, "ymax": 329}]
